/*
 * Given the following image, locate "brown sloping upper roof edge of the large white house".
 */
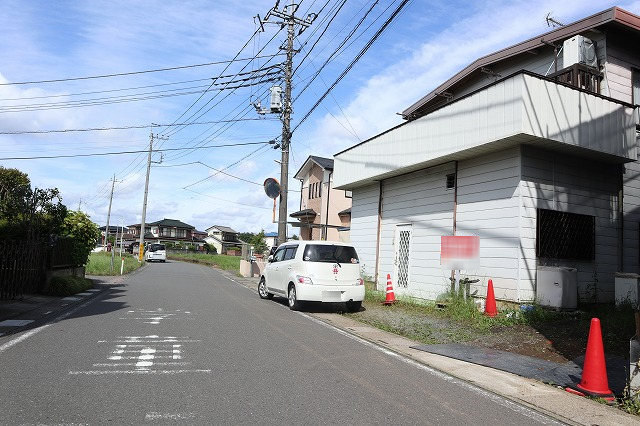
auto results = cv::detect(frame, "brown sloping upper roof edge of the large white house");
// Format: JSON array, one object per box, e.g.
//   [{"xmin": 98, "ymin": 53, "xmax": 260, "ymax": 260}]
[{"xmin": 402, "ymin": 7, "xmax": 640, "ymax": 120}]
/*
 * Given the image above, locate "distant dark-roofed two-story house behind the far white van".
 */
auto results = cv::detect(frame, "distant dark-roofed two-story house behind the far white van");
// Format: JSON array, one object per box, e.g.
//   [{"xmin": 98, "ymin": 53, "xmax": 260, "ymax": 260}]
[{"xmin": 129, "ymin": 219, "xmax": 204, "ymax": 250}]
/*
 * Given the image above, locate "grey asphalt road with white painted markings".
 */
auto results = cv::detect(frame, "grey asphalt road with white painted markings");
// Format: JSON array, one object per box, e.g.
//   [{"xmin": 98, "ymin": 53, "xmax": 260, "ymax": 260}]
[{"xmin": 0, "ymin": 261, "xmax": 564, "ymax": 425}]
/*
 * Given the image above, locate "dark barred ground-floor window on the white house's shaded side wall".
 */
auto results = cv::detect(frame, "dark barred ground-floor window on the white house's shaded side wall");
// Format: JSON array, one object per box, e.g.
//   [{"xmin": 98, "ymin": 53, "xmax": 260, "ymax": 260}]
[{"xmin": 536, "ymin": 209, "xmax": 595, "ymax": 260}]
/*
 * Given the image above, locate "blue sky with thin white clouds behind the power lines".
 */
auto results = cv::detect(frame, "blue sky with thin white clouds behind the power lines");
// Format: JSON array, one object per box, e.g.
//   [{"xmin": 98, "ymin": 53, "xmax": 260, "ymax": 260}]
[{"xmin": 0, "ymin": 0, "xmax": 640, "ymax": 232}]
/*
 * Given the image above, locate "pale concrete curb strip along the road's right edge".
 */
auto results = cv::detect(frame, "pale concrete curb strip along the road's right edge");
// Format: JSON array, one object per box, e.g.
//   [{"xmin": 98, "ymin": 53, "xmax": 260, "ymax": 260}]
[{"xmin": 219, "ymin": 270, "xmax": 639, "ymax": 426}]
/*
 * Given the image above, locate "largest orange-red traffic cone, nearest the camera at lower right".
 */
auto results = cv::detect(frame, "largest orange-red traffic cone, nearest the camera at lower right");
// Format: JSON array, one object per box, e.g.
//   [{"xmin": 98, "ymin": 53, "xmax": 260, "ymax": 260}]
[{"xmin": 566, "ymin": 318, "xmax": 615, "ymax": 401}]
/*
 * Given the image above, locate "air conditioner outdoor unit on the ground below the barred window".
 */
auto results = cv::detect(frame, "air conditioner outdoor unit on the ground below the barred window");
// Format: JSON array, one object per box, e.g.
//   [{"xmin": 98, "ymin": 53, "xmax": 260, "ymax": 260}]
[{"xmin": 536, "ymin": 266, "xmax": 578, "ymax": 309}]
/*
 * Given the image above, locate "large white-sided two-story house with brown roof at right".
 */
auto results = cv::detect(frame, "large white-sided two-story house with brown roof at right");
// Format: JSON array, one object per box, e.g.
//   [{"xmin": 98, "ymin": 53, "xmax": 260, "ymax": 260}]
[{"xmin": 334, "ymin": 7, "xmax": 640, "ymax": 302}]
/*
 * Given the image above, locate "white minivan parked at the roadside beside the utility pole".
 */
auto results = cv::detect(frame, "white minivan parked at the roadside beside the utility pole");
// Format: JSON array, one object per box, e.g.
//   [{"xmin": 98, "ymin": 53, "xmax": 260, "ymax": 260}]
[{"xmin": 258, "ymin": 241, "xmax": 364, "ymax": 311}]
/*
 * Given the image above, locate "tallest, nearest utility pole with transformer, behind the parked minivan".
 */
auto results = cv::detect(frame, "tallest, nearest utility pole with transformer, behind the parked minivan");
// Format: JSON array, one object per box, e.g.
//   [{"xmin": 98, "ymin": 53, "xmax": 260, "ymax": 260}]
[{"xmin": 258, "ymin": 0, "xmax": 317, "ymax": 244}]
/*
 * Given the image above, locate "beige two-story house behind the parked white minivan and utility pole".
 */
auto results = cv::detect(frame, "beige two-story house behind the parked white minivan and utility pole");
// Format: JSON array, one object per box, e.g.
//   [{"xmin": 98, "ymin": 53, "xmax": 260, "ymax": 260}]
[{"xmin": 289, "ymin": 155, "xmax": 351, "ymax": 241}]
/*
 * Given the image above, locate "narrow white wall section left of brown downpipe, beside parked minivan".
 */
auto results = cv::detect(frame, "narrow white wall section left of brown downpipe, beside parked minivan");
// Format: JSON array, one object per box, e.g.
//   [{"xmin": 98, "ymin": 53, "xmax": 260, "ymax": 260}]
[{"xmin": 350, "ymin": 183, "xmax": 380, "ymax": 279}]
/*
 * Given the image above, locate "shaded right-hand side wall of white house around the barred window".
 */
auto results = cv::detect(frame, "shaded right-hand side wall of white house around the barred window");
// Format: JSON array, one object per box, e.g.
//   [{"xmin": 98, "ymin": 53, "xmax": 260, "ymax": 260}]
[{"xmin": 521, "ymin": 146, "xmax": 619, "ymax": 302}]
